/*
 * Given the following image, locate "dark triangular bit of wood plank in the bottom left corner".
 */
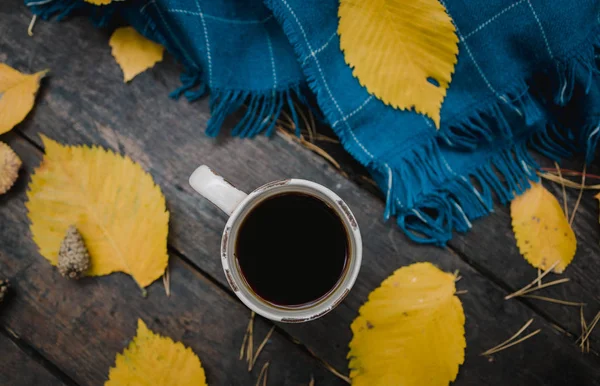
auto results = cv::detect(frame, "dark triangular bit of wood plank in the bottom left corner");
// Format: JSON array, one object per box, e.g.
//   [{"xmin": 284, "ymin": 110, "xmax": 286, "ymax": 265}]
[{"xmin": 0, "ymin": 333, "xmax": 65, "ymax": 386}]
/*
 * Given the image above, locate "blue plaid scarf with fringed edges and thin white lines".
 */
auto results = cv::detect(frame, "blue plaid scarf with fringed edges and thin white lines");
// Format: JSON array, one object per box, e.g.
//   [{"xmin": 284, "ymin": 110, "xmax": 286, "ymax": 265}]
[{"xmin": 26, "ymin": 0, "xmax": 600, "ymax": 245}]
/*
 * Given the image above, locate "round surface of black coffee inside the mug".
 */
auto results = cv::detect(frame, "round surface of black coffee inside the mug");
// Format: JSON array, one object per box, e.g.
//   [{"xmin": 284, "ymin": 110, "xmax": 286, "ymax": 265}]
[{"xmin": 235, "ymin": 193, "xmax": 349, "ymax": 307}]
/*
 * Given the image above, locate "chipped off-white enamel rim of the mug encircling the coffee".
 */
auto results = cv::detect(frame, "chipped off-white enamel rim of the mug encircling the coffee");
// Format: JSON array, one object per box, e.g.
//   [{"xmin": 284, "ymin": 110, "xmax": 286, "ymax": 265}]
[{"xmin": 221, "ymin": 178, "xmax": 362, "ymax": 323}]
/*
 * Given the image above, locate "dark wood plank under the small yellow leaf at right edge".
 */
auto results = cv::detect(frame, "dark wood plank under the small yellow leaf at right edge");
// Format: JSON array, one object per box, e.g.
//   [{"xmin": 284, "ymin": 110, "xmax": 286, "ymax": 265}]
[{"xmin": 450, "ymin": 155, "xmax": 600, "ymax": 342}]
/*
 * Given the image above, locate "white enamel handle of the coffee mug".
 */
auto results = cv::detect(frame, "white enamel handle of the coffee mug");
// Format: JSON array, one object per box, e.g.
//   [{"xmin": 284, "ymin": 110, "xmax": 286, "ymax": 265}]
[{"xmin": 189, "ymin": 165, "xmax": 248, "ymax": 216}]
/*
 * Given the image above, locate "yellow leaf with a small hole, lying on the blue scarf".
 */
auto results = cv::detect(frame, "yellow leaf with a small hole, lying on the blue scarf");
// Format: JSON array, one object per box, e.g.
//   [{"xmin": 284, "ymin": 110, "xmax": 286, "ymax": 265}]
[{"xmin": 338, "ymin": 0, "xmax": 458, "ymax": 128}]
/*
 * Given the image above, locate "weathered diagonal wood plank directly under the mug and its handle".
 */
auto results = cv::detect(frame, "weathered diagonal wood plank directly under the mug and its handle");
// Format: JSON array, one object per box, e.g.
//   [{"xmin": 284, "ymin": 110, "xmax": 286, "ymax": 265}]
[{"xmin": 0, "ymin": 2, "xmax": 600, "ymax": 385}]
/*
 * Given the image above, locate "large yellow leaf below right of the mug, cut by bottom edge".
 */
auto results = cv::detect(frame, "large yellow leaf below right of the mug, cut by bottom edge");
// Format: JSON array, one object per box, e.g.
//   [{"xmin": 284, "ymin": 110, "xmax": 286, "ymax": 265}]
[{"xmin": 348, "ymin": 263, "xmax": 466, "ymax": 386}]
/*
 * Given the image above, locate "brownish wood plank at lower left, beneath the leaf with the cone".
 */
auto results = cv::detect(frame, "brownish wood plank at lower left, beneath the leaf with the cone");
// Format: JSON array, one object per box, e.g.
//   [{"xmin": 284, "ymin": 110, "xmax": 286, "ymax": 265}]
[{"xmin": 0, "ymin": 134, "xmax": 343, "ymax": 385}]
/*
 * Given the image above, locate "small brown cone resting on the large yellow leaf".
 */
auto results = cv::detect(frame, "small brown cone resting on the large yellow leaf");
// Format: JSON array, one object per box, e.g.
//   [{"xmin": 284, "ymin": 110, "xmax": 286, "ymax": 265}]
[{"xmin": 58, "ymin": 225, "xmax": 90, "ymax": 279}]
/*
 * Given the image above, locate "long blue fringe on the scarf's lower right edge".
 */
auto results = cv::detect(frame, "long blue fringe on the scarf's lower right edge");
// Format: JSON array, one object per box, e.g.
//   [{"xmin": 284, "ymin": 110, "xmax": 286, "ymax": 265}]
[{"xmin": 392, "ymin": 32, "xmax": 600, "ymax": 246}]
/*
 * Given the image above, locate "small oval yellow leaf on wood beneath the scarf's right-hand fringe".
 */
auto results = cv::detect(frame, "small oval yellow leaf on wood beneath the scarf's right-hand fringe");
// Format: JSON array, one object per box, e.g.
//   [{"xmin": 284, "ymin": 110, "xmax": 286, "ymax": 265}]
[{"xmin": 510, "ymin": 183, "xmax": 577, "ymax": 273}]
